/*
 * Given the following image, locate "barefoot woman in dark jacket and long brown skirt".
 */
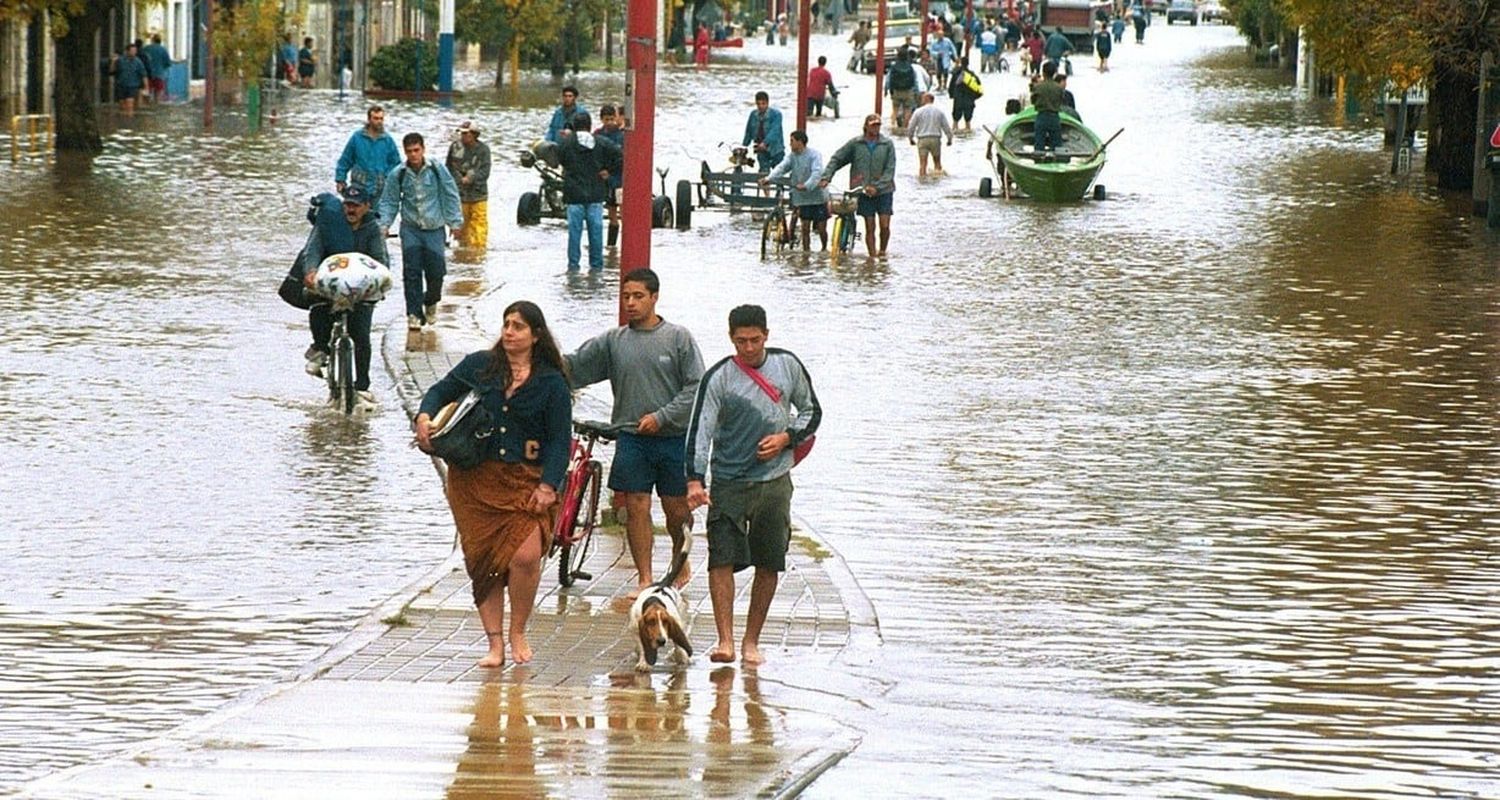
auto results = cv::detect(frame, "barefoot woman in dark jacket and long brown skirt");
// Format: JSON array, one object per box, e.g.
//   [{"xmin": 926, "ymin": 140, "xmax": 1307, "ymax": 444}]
[{"xmin": 416, "ymin": 300, "xmax": 573, "ymax": 666}]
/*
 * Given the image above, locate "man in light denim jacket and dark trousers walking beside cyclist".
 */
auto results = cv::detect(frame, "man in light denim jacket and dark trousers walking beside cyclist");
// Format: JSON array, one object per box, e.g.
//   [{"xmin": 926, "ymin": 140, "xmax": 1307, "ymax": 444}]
[{"xmin": 378, "ymin": 132, "xmax": 464, "ymax": 330}]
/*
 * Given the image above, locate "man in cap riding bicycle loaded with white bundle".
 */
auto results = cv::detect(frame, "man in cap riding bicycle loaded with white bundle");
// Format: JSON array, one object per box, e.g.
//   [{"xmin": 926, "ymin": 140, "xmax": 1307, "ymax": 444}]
[{"xmin": 297, "ymin": 183, "xmax": 390, "ymax": 405}]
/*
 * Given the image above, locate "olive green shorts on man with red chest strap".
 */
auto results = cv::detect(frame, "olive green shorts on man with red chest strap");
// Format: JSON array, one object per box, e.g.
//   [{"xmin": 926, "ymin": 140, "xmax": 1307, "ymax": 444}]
[{"xmin": 705, "ymin": 473, "xmax": 792, "ymax": 572}]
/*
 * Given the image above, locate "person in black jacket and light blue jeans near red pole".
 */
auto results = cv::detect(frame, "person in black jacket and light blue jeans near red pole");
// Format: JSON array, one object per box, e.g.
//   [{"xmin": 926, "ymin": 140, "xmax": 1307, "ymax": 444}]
[{"xmin": 558, "ymin": 111, "xmax": 624, "ymax": 272}]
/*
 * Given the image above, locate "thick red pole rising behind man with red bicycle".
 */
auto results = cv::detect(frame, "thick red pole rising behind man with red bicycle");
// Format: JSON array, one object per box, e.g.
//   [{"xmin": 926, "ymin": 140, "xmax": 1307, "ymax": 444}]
[{"xmin": 620, "ymin": 0, "xmax": 657, "ymax": 324}]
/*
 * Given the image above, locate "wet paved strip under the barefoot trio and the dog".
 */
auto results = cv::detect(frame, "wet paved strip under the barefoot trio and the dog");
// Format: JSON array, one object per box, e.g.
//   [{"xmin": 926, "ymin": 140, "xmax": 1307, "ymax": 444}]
[{"xmin": 21, "ymin": 276, "xmax": 881, "ymax": 798}]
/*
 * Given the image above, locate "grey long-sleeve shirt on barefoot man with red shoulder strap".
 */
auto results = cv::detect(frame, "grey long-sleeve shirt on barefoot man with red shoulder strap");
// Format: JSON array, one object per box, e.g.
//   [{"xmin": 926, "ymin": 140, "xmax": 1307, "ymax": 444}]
[{"xmin": 686, "ymin": 347, "xmax": 824, "ymax": 482}]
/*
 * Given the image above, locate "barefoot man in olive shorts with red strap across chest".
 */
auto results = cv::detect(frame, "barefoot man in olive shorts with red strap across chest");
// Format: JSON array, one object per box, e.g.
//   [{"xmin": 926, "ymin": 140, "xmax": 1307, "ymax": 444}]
[{"xmin": 687, "ymin": 303, "xmax": 828, "ymax": 666}]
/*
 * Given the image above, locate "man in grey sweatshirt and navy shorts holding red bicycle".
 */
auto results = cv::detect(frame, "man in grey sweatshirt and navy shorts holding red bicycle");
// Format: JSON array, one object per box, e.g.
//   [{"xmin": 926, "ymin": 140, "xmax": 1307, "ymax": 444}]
[{"xmin": 564, "ymin": 269, "xmax": 704, "ymax": 597}]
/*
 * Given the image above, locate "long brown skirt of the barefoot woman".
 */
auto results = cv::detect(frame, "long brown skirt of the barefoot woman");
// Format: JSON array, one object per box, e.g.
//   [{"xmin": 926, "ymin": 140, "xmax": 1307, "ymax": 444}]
[{"xmin": 447, "ymin": 461, "xmax": 552, "ymax": 605}]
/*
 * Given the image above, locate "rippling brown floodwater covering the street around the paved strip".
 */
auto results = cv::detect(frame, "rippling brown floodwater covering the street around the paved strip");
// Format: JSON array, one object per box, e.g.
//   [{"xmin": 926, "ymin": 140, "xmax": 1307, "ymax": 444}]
[{"xmin": 0, "ymin": 24, "xmax": 1500, "ymax": 797}]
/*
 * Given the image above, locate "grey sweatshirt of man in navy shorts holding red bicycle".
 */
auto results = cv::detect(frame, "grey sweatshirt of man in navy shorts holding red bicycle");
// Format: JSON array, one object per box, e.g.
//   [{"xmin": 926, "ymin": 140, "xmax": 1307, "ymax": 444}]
[{"xmin": 564, "ymin": 320, "xmax": 704, "ymax": 437}]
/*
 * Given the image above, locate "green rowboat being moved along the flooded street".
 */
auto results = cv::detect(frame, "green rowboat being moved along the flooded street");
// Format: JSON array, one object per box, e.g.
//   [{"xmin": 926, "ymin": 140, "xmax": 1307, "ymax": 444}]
[{"xmin": 990, "ymin": 107, "xmax": 1104, "ymax": 203}]
